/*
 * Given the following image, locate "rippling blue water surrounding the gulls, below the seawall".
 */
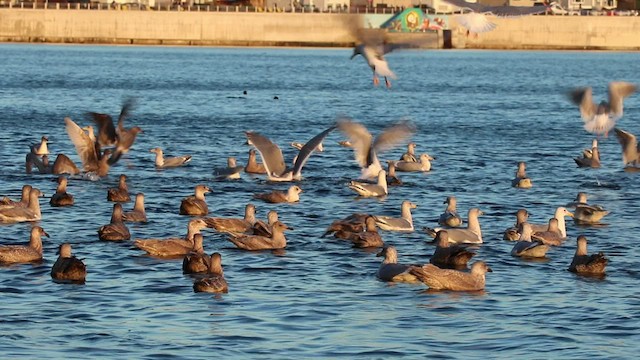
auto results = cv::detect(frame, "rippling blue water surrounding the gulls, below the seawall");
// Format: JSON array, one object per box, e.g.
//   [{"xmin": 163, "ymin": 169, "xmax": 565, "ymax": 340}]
[{"xmin": 0, "ymin": 45, "xmax": 640, "ymax": 359}]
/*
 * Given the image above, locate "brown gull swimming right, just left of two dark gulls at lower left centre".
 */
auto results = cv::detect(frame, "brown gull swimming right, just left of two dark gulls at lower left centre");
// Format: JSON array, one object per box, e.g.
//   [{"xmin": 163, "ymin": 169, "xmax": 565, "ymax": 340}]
[{"xmin": 133, "ymin": 219, "xmax": 207, "ymax": 257}]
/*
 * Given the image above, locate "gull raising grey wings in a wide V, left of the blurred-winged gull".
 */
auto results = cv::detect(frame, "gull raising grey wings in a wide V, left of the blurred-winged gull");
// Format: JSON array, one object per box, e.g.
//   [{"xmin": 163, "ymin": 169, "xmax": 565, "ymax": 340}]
[{"xmin": 246, "ymin": 126, "xmax": 336, "ymax": 181}]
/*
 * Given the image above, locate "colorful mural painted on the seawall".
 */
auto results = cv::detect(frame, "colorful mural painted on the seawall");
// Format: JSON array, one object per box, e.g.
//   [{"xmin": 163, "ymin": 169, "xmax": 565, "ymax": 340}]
[{"xmin": 380, "ymin": 8, "xmax": 449, "ymax": 32}]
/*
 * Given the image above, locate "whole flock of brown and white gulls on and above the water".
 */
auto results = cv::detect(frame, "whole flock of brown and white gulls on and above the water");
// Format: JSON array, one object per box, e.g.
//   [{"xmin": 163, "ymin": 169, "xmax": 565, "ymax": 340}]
[{"xmin": 0, "ymin": 43, "xmax": 640, "ymax": 292}]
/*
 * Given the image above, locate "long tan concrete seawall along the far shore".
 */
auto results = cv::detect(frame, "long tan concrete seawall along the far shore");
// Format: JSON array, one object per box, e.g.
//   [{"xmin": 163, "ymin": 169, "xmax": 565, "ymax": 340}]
[{"xmin": 0, "ymin": 8, "xmax": 640, "ymax": 50}]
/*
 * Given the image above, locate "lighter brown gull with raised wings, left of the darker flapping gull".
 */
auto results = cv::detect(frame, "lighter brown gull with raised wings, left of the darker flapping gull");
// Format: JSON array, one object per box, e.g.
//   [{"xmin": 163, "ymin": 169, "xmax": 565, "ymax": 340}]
[{"xmin": 64, "ymin": 117, "xmax": 111, "ymax": 177}]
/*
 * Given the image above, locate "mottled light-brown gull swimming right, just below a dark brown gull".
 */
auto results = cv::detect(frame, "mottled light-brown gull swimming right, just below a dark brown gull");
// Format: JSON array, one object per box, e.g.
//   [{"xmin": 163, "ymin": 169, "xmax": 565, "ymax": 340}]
[{"xmin": 409, "ymin": 261, "xmax": 493, "ymax": 291}]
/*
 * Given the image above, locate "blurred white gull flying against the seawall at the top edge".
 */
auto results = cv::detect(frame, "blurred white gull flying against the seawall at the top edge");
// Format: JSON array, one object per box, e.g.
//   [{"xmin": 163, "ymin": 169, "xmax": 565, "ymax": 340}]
[{"xmin": 445, "ymin": 0, "xmax": 547, "ymax": 36}]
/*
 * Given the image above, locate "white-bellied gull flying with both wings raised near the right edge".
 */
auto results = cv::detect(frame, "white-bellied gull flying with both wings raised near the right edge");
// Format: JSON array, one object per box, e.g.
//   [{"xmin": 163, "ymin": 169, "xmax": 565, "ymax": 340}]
[{"xmin": 569, "ymin": 81, "xmax": 637, "ymax": 136}]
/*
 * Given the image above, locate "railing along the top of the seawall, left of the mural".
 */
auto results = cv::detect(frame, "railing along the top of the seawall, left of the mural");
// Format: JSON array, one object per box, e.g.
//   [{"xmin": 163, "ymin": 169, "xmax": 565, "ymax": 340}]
[{"xmin": 0, "ymin": 0, "xmax": 404, "ymax": 14}]
